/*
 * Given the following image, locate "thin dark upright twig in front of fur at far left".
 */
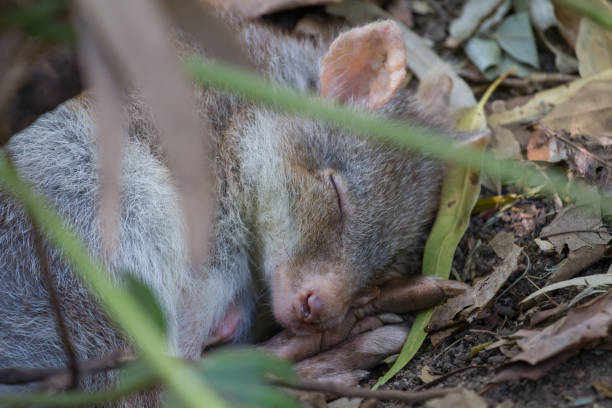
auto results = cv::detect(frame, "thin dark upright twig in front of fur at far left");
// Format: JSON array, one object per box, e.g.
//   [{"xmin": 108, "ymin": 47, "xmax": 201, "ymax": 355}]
[{"xmin": 30, "ymin": 217, "xmax": 79, "ymax": 389}]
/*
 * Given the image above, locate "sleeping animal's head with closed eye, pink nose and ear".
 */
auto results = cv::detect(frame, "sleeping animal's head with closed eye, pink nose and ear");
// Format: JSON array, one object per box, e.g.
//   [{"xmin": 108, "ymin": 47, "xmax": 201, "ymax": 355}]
[{"xmin": 247, "ymin": 21, "xmax": 442, "ymax": 333}]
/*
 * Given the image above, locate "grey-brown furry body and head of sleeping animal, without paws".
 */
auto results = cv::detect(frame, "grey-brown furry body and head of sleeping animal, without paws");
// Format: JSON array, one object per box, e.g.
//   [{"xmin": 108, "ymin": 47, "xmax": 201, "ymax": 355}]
[{"xmin": 0, "ymin": 14, "xmax": 450, "ymax": 404}]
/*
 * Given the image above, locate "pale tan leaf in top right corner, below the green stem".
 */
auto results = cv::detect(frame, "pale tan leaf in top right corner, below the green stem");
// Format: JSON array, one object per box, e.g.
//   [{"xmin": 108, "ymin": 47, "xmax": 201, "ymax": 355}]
[{"xmin": 576, "ymin": 0, "xmax": 612, "ymax": 77}]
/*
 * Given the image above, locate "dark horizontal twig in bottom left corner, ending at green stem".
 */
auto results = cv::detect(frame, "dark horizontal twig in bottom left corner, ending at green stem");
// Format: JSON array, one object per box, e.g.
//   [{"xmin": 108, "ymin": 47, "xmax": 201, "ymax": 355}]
[{"xmin": 0, "ymin": 352, "xmax": 135, "ymax": 389}]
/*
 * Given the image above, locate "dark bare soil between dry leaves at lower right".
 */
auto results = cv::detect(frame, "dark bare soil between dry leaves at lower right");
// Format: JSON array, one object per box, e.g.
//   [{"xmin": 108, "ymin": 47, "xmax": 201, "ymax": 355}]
[{"xmin": 367, "ymin": 191, "xmax": 612, "ymax": 407}]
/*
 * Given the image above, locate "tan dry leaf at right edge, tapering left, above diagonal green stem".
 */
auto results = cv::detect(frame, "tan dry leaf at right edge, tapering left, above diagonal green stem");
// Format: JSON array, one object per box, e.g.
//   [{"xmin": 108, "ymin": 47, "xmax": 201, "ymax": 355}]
[{"xmin": 541, "ymin": 80, "xmax": 612, "ymax": 138}]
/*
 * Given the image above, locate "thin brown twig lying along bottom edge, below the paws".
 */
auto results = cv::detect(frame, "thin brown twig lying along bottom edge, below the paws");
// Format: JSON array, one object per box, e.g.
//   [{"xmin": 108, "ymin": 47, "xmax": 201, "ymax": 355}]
[{"xmin": 269, "ymin": 379, "xmax": 459, "ymax": 404}]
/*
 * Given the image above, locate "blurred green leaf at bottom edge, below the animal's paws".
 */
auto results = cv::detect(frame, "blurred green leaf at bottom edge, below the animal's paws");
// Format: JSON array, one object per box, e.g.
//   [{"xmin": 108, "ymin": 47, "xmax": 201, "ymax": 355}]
[{"xmin": 199, "ymin": 349, "xmax": 299, "ymax": 407}]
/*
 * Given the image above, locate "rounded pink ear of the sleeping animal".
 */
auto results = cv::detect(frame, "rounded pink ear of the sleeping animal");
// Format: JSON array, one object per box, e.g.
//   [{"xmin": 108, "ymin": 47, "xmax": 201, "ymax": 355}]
[{"xmin": 321, "ymin": 20, "xmax": 406, "ymax": 109}]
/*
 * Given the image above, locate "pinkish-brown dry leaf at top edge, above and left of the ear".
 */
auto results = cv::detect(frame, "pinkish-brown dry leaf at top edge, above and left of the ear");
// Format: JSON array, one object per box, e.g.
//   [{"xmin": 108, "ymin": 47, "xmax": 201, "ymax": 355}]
[{"xmin": 206, "ymin": 0, "xmax": 342, "ymax": 18}]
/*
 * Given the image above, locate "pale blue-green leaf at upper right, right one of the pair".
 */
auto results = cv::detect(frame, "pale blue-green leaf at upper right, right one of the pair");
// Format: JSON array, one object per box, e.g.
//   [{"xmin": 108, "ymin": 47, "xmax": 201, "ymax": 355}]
[{"xmin": 494, "ymin": 12, "xmax": 540, "ymax": 68}]
